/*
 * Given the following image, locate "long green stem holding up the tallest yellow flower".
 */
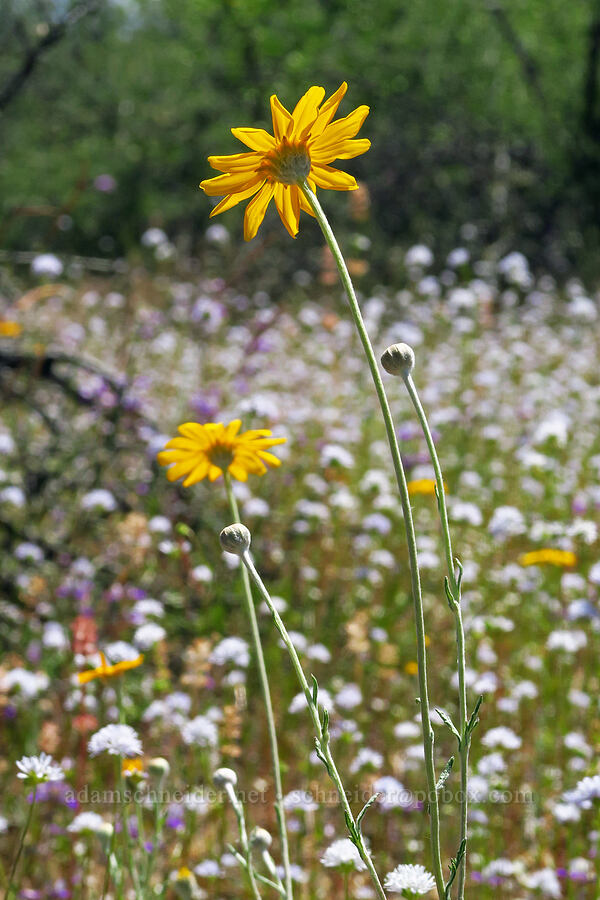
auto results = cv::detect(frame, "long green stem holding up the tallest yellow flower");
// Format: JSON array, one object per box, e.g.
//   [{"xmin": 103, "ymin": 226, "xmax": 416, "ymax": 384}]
[{"xmin": 299, "ymin": 180, "xmax": 445, "ymax": 900}]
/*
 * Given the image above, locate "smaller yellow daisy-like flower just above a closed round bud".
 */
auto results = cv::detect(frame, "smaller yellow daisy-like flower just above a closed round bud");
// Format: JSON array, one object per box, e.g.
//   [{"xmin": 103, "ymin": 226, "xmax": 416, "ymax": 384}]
[{"xmin": 157, "ymin": 419, "xmax": 285, "ymax": 487}]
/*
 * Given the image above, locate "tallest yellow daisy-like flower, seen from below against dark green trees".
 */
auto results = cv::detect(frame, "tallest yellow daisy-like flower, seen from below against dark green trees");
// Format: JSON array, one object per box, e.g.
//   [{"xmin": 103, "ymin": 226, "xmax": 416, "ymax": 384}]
[{"xmin": 200, "ymin": 82, "xmax": 371, "ymax": 241}]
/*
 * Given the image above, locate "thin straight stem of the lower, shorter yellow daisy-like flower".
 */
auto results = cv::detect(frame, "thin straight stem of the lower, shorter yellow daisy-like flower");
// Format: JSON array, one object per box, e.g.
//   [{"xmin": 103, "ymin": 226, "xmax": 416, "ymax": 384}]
[{"xmin": 225, "ymin": 472, "xmax": 293, "ymax": 900}]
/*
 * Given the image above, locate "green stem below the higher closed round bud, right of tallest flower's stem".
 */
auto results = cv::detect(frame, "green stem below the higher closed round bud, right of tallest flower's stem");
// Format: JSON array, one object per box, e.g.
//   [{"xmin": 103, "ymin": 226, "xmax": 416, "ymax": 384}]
[{"xmin": 402, "ymin": 372, "xmax": 471, "ymax": 900}]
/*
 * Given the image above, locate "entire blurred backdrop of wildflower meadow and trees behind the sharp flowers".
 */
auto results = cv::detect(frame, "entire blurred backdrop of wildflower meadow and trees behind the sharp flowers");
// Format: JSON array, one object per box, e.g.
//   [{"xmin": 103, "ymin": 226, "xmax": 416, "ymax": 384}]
[{"xmin": 0, "ymin": 0, "xmax": 600, "ymax": 900}]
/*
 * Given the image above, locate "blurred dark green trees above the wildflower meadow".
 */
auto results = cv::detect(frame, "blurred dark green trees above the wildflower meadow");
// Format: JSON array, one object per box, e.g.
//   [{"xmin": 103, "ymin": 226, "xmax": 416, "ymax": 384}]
[{"xmin": 0, "ymin": 0, "xmax": 600, "ymax": 277}]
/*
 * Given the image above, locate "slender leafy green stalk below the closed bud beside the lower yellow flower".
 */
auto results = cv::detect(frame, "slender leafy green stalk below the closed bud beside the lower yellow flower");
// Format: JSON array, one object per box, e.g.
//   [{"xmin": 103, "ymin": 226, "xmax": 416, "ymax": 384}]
[{"xmin": 230, "ymin": 526, "xmax": 386, "ymax": 900}]
